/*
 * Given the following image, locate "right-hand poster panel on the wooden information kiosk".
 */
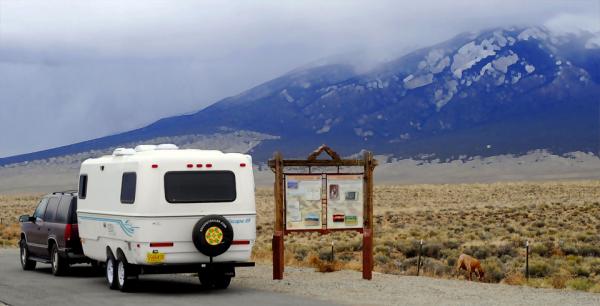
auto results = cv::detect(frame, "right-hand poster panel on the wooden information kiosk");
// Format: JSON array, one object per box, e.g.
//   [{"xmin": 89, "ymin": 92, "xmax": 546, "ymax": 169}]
[{"xmin": 327, "ymin": 174, "xmax": 363, "ymax": 229}]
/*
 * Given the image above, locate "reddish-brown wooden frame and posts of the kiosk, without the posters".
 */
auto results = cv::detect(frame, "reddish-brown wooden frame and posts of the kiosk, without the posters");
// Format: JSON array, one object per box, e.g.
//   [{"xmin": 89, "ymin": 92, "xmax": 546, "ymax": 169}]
[{"xmin": 269, "ymin": 145, "xmax": 377, "ymax": 280}]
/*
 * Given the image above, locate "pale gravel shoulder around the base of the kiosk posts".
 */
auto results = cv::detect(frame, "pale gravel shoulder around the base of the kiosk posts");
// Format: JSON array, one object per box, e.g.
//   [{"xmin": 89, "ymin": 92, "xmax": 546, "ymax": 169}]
[{"xmin": 234, "ymin": 265, "xmax": 600, "ymax": 306}]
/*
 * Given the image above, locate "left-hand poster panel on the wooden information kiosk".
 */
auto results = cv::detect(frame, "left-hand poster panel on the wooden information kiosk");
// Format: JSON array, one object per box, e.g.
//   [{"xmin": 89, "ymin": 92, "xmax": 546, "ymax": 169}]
[{"xmin": 285, "ymin": 175, "xmax": 323, "ymax": 230}]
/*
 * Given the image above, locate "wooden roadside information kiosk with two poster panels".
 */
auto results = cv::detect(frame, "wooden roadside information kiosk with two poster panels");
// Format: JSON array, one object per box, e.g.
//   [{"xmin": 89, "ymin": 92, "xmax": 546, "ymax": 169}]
[{"xmin": 269, "ymin": 145, "xmax": 377, "ymax": 280}]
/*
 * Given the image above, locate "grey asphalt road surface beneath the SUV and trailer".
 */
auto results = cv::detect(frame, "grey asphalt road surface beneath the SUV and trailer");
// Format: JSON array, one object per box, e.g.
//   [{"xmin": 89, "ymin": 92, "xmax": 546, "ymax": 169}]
[{"xmin": 0, "ymin": 249, "xmax": 331, "ymax": 306}]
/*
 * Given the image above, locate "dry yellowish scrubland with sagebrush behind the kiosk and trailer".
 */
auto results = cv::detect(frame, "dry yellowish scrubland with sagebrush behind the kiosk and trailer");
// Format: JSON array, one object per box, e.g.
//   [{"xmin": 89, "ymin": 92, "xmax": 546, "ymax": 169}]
[{"xmin": 0, "ymin": 181, "xmax": 600, "ymax": 293}]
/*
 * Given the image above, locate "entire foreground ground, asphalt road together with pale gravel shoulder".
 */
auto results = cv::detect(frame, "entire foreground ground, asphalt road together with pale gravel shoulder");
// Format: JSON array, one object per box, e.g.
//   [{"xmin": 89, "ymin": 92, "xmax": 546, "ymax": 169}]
[{"xmin": 0, "ymin": 249, "xmax": 600, "ymax": 306}]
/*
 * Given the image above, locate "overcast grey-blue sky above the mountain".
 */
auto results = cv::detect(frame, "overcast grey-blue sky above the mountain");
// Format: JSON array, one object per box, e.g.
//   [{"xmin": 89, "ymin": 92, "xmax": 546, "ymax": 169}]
[{"xmin": 0, "ymin": 0, "xmax": 600, "ymax": 157}]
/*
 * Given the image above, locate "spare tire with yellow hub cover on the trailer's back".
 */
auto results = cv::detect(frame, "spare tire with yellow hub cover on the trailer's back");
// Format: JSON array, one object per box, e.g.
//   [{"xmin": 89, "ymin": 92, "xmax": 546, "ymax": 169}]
[{"xmin": 192, "ymin": 215, "xmax": 233, "ymax": 257}]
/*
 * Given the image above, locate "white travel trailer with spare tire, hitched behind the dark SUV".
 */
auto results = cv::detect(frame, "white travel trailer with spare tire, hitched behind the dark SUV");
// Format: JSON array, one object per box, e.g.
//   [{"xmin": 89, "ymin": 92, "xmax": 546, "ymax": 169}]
[{"xmin": 77, "ymin": 144, "xmax": 256, "ymax": 290}]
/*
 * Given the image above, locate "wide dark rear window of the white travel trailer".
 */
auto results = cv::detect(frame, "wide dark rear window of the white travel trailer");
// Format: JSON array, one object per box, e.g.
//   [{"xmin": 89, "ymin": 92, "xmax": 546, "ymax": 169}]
[{"xmin": 165, "ymin": 171, "xmax": 236, "ymax": 203}]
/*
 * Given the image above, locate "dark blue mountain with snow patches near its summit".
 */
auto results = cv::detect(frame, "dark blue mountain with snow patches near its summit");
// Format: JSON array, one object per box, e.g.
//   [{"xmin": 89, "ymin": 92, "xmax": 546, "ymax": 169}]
[{"xmin": 0, "ymin": 27, "xmax": 600, "ymax": 164}]
